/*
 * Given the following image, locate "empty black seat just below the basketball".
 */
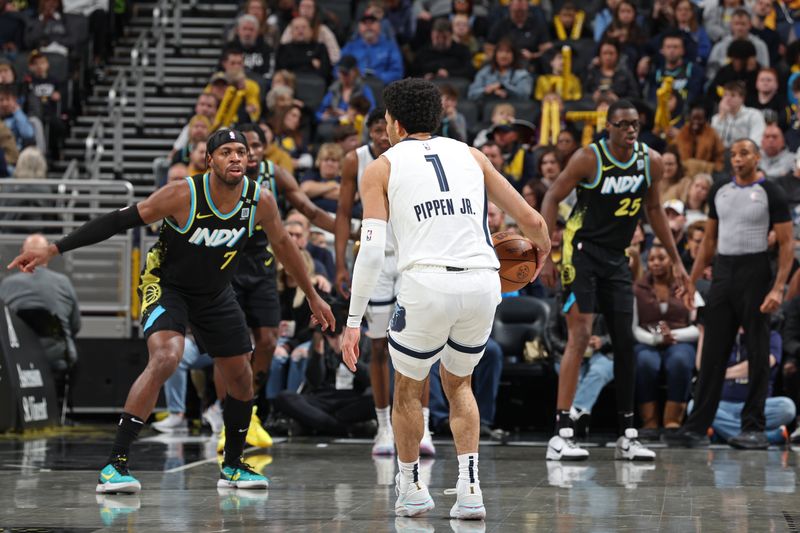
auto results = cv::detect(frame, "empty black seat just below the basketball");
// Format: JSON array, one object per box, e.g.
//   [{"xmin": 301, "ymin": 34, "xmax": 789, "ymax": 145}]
[{"xmin": 492, "ymin": 296, "xmax": 550, "ymax": 362}]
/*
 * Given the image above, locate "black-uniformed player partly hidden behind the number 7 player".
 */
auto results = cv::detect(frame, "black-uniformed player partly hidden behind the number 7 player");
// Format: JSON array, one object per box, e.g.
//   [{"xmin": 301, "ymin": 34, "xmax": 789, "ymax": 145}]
[{"xmin": 232, "ymin": 124, "xmax": 334, "ymax": 420}]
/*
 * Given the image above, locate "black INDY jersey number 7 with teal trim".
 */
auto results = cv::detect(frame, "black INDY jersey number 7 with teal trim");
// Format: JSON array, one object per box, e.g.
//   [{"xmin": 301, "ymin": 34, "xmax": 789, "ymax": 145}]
[{"xmin": 141, "ymin": 170, "xmax": 260, "ymax": 304}]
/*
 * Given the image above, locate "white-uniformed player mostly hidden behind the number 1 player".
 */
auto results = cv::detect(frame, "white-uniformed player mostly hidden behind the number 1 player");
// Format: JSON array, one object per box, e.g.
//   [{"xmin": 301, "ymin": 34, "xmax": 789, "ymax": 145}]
[{"xmin": 335, "ymin": 108, "xmax": 436, "ymax": 456}]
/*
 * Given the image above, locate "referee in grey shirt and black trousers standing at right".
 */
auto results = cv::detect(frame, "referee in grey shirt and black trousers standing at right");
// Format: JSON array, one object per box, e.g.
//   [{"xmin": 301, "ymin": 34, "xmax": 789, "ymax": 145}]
[{"xmin": 665, "ymin": 139, "xmax": 793, "ymax": 449}]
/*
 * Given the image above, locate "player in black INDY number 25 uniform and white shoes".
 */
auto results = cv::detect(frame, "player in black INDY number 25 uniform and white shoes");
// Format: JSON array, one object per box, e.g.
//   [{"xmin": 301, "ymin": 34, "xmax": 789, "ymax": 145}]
[{"xmin": 542, "ymin": 100, "xmax": 688, "ymax": 461}]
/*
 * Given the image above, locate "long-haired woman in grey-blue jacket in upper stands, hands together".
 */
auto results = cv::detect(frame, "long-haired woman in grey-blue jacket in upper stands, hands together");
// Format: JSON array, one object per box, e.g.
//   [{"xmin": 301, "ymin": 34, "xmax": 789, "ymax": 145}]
[{"xmin": 467, "ymin": 39, "xmax": 533, "ymax": 100}]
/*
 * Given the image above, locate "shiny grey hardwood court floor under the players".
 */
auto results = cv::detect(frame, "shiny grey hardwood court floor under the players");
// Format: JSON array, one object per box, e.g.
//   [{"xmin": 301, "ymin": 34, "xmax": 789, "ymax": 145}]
[{"xmin": 0, "ymin": 426, "xmax": 800, "ymax": 533}]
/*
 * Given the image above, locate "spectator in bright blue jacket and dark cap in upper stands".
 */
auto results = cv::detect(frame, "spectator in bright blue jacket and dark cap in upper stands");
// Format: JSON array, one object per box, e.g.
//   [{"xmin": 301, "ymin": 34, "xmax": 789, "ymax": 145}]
[{"xmin": 342, "ymin": 8, "xmax": 403, "ymax": 84}]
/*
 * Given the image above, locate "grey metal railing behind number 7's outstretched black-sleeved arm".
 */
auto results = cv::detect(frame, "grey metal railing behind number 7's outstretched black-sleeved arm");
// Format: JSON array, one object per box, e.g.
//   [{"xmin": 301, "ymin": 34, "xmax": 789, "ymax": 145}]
[{"xmin": 0, "ymin": 179, "xmax": 135, "ymax": 338}]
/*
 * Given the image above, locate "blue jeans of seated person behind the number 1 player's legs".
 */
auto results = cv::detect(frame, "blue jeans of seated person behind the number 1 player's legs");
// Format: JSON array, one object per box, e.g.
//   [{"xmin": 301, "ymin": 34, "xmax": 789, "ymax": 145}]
[{"xmin": 430, "ymin": 338, "xmax": 503, "ymax": 427}]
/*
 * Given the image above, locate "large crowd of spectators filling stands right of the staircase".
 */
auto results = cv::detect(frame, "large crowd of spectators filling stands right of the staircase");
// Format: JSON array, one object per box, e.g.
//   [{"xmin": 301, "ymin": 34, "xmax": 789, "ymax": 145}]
[{"xmin": 147, "ymin": 0, "xmax": 800, "ymax": 442}]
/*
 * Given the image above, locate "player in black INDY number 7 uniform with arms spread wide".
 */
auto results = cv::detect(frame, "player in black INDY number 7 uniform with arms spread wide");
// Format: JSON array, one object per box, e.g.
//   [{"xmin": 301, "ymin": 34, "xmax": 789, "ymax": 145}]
[{"xmin": 9, "ymin": 129, "xmax": 334, "ymax": 493}]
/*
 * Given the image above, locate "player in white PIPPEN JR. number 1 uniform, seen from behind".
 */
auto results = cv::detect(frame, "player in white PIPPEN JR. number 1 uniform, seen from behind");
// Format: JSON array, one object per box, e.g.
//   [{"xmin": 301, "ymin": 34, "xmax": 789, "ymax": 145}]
[{"xmin": 342, "ymin": 78, "xmax": 550, "ymax": 519}]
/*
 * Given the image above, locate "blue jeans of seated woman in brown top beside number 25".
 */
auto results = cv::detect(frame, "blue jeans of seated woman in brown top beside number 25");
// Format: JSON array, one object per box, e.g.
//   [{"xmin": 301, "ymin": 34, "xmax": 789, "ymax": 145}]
[{"xmin": 633, "ymin": 342, "xmax": 697, "ymax": 403}]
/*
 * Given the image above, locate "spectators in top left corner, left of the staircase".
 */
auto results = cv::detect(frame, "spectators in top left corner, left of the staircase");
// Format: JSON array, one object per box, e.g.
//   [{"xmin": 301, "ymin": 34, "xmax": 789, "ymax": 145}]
[{"xmin": 0, "ymin": 0, "xmax": 122, "ymax": 172}]
